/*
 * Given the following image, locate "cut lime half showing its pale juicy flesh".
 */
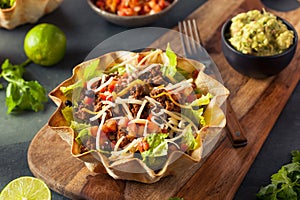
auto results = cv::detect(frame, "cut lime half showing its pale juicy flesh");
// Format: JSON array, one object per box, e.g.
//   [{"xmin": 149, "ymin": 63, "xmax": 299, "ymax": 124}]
[{"xmin": 0, "ymin": 176, "xmax": 51, "ymax": 200}]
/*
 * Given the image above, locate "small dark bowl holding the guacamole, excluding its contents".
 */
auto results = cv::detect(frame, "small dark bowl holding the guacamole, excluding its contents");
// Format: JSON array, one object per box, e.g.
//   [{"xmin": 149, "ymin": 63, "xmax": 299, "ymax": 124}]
[{"xmin": 221, "ymin": 17, "xmax": 298, "ymax": 78}]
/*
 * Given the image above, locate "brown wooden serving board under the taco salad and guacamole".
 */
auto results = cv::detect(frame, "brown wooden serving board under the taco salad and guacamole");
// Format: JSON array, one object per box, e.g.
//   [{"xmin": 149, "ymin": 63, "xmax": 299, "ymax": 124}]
[{"xmin": 28, "ymin": 0, "xmax": 300, "ymax": 200}]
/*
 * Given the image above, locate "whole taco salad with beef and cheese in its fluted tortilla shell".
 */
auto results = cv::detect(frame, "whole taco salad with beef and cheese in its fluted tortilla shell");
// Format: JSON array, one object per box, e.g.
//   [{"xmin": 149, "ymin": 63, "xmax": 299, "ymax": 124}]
[{"xmin": 48, "ymin": 46, "xmax": 229, "ymax": 183}]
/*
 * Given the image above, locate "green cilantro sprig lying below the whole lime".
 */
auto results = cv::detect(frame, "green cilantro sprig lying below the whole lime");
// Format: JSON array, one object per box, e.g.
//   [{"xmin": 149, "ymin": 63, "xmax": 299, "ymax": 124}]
[{"xmin": 0, "ymin": 59, "xmax": 48, "ymax": 114}]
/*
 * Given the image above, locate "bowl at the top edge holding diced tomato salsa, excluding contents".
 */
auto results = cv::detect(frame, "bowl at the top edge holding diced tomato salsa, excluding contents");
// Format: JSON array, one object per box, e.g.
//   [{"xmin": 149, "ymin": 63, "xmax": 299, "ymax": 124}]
[{"xmin": 87, "ymin": 0, "xmax": 179, "ymax": 27}]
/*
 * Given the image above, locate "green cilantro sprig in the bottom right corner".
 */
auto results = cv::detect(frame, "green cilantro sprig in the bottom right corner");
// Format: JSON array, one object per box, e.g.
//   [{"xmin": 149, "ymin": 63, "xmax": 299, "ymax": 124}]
[{"xmin": 256, "ymin": 150, "xmax": 300, "ymax": 200}]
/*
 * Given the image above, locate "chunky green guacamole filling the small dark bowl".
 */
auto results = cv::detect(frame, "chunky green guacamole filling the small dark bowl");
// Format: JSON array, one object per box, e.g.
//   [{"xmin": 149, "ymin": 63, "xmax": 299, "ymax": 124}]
[{"xmin": 229, "ymin": 10, "xmax": 294, "ymax": 56}]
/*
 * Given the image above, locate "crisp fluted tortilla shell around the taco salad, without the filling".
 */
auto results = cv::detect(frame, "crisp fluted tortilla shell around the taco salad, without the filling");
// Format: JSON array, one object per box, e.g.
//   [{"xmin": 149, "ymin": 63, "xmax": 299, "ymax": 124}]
[{"xmin": 48, "ymin": 49, "xmax": 229, "ymax": 183}]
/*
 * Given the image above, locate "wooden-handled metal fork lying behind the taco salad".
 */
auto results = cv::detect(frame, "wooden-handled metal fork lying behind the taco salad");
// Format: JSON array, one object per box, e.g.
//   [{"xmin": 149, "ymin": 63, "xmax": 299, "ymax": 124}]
[{"xmin": 178, "ymin": 19, "xmax": 247, "ymax": 147}]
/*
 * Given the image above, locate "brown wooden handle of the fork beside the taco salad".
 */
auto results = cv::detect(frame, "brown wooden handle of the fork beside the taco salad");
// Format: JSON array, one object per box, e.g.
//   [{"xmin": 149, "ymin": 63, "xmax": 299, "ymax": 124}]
[{"xmin": 226, "ymin": 100, "xmax": 247, "ymax": 147}]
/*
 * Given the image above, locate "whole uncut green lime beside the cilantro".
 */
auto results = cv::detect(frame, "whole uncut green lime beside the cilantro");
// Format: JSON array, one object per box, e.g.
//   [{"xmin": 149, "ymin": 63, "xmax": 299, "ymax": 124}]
[{"xmin": 24, "ymin": 23, "xmax": 67, "ymax": 66}]
